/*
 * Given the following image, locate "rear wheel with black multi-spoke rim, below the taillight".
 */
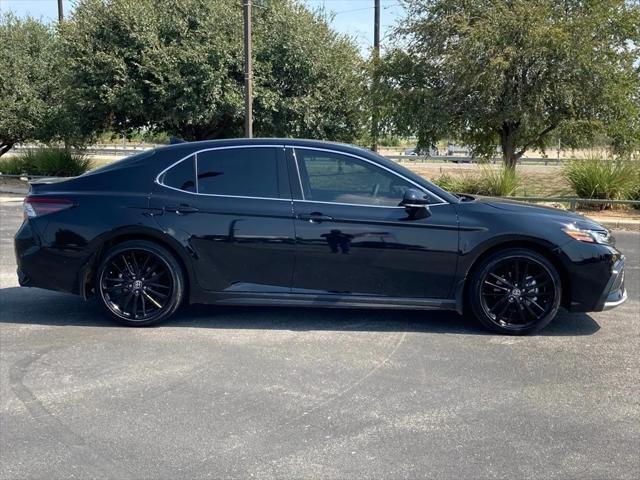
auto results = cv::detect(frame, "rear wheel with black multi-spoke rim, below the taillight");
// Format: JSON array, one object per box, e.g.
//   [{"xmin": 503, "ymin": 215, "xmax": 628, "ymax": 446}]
[{"xmin": 96, "ymin": 240, "xmax": 185, "ymax": 327}]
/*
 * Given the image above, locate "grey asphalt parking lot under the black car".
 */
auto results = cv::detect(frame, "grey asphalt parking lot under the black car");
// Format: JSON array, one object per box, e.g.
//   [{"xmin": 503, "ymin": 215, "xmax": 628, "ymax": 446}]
[{"xmin": 0, "ymin": 196, "xmax": 640, "ymax": 479}]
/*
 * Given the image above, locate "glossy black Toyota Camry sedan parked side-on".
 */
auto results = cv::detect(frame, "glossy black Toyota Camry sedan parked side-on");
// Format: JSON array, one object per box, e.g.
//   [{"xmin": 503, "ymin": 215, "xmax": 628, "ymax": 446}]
[{"xmin": 15, "ymin": 139, "xmax": 626, "ymax": 334}]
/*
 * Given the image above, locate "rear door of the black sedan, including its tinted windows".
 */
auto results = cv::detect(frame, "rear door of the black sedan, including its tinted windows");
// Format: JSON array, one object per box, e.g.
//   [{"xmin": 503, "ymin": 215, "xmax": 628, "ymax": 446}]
[{"xmin": 151, "ymin": 145, "xmax": 295, "ymax": 293}]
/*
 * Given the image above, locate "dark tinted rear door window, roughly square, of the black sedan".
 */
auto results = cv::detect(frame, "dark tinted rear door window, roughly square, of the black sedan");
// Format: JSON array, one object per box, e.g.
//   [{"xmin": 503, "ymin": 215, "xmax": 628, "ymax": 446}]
[{"xmin": 197, "ymin": 147, "xmax": 280, "ymax": 198}]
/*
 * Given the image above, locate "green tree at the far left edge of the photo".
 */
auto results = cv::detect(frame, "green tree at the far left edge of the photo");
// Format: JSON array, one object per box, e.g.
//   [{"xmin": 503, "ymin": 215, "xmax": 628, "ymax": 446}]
[{"xmin": 0, "ymin": 14, "xmax": 54, "ymax": 156}]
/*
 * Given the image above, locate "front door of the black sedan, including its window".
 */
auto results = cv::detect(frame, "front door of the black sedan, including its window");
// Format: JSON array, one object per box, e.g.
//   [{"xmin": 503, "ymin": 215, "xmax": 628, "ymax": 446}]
[{"xmin": 287, "ymin": 147, "xmax": 458, "ymax": 299}]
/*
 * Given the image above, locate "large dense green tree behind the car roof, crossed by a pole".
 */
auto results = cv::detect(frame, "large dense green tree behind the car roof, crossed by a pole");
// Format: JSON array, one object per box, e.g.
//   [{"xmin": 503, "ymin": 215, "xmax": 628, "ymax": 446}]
[{"xmin": 62, "ymin": 0, "xmax": 364, "ymax": 140}]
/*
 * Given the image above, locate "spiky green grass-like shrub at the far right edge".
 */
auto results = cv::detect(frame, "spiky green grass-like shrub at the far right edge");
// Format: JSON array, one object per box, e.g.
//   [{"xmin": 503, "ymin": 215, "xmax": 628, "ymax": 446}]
[{"xmin": 564, "ymin": 157, "xmax": 638, "ymax": 200}]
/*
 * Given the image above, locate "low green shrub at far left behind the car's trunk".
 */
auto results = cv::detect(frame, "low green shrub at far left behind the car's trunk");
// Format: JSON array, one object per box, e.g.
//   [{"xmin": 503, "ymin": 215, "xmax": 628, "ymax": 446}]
[{"xmin": 0, "ymin": 148, "xmax": 91, "ymax": 177}]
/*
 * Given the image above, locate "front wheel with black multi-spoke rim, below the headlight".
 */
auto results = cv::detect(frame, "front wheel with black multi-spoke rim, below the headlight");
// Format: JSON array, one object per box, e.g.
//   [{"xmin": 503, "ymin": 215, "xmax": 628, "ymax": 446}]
[{"xmin": 467, "ymin": 248, "xmax": 562, "ymax": 335}]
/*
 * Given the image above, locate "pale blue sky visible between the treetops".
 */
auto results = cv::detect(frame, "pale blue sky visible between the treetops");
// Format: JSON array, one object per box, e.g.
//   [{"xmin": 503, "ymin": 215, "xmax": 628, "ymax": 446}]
[{"xmin": 0, "ymin": 0, "xmax": 403, "ymax": 55}]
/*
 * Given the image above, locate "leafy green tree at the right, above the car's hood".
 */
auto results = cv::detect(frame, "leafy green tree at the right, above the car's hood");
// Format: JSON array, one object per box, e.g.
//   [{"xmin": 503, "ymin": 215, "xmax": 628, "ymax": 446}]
[{"xmin": 381, "ymin": 0, "xmax": 640, "ymax": 168}]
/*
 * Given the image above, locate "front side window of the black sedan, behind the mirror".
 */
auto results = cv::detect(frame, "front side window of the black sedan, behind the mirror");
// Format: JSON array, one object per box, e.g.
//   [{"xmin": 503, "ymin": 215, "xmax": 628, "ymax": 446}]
[{"xmin": 295, "ymin": 148, "xmax": 416, "ymax": 206}]
